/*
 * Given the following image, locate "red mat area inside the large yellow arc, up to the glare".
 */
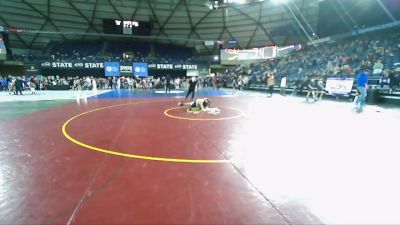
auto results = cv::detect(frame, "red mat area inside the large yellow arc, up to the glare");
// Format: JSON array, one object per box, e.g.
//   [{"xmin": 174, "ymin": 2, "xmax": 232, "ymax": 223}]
[{"xmin": 65, "ymin": 101, "xmax": 242, "ymax": 160}]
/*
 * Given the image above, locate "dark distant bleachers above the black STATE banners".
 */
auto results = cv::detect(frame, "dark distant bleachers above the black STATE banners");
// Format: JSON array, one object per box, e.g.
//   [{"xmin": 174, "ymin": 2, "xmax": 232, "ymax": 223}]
[{"xmin": 14, "ymin": 40, "xmax": 199, "ymax": 64}]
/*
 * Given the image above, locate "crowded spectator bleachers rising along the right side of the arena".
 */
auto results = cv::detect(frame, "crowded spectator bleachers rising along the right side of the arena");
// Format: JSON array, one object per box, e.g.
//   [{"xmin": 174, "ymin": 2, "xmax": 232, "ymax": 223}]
[{"xmin": 220, "ymin": 34, "xmax": 400, "ymax": 104}]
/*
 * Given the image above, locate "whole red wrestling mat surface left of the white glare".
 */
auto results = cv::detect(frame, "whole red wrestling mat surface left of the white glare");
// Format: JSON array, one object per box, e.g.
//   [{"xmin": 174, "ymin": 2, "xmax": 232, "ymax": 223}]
[{"xmin": 0, "ymin": 99, "xmax": 285, "ymax": 224}]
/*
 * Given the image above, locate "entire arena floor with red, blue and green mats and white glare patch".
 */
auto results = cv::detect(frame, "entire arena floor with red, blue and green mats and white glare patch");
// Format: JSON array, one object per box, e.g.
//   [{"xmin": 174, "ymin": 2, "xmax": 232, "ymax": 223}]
[{"xmin": 0, "ymin": 89, "xmax": 400, "ymax": 224}]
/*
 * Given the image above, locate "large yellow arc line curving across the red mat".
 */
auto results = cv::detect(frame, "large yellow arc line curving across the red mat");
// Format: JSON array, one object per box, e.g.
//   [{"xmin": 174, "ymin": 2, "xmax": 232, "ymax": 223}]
[{"xmin": 61, "ymin": 102, "xmax": 230, "ymax": 163}]
